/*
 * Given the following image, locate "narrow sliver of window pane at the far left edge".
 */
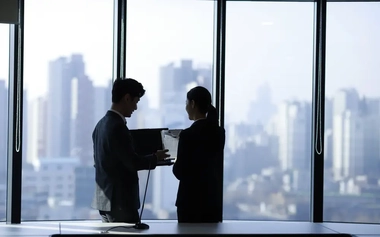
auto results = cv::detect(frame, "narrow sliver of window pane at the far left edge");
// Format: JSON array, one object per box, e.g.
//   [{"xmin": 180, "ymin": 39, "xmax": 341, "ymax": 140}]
[{"xmin": 0, "ymin": 24, "xmax": 9, "ymax": 221}]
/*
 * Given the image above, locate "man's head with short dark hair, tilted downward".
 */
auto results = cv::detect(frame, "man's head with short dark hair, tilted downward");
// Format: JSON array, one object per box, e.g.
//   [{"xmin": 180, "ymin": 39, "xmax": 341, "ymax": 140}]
[{"xmin": 112, "ymin": 78, "xmax": 145, "ymax": 117}]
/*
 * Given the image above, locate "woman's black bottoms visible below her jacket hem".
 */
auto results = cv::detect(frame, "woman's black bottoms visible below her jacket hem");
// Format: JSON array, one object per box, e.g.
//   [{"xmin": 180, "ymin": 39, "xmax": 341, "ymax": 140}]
[{"xmin": 177, "ymin": 207, "xmax": 220, "ymax": 223}]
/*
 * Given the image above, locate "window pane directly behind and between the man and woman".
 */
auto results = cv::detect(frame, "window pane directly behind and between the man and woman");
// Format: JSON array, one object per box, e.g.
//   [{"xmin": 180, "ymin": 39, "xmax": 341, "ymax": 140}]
[{"xmin": 126, "ymin": 0, "xmax": 214, "ymax": 219}]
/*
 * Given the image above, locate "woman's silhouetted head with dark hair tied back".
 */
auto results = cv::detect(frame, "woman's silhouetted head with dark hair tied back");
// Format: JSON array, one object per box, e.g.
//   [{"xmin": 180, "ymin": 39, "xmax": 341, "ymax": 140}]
[{"xmin": 186, "ymin": 86, "xmax": 218, "ymax": 123}]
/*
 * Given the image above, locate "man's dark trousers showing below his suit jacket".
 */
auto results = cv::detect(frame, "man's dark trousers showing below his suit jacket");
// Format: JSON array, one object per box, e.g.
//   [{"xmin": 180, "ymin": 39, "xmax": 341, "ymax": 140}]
[{"xmin": 99, "ymin": 208, "xmax": 140, "ymax": 223}]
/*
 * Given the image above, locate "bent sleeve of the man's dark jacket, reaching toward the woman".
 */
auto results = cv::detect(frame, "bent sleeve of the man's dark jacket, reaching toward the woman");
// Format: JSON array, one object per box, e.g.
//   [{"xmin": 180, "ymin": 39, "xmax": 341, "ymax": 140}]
[{"xmin": 113, "ymin": 123, "xmax": 157, "ymax": 171}]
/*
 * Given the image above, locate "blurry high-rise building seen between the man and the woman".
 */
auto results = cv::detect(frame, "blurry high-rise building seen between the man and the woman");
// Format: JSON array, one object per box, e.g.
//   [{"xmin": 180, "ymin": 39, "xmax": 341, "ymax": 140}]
[{"xmin": 152, "ymin": 60, "xmax": 212, "ymax": 217}]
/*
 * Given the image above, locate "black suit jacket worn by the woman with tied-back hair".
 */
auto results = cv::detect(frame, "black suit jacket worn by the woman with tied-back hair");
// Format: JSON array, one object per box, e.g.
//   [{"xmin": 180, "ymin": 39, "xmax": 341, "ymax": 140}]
[{"xmin": 173, "ymin": 119, "xmax": 225, "ymax": 210}]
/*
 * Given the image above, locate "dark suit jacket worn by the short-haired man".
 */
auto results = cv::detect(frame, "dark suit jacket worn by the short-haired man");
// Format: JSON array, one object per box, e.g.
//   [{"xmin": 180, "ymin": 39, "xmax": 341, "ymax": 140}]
[{"xmin": 91, "ymin": 111, "xmax": 157, "ymax": 211}]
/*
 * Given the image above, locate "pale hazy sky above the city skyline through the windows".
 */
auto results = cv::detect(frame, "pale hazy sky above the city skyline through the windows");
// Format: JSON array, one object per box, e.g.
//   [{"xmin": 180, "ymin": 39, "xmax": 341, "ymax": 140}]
[{"xmin": 0, "ymin": 0, "xmax": 380, "ymax": 121}]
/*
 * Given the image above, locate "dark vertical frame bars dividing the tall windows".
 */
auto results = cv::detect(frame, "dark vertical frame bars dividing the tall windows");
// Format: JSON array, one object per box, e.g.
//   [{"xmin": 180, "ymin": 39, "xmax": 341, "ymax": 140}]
[{"xmin": 6, "ymin": 0, "xmax": 380, "ymax": 224}]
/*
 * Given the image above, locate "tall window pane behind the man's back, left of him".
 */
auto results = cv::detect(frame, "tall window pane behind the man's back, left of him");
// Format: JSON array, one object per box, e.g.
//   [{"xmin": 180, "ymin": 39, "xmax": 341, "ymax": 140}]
[{"xmin": 22, "ymin": 0, "xmax": 113, "ymax": 220}]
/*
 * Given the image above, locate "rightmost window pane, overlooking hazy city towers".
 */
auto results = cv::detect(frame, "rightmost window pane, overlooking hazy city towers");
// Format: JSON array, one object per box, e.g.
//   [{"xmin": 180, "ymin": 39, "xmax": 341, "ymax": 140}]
[{"xmin": 324, "ymin": 2, "xmax": 380, "ymax": 223}]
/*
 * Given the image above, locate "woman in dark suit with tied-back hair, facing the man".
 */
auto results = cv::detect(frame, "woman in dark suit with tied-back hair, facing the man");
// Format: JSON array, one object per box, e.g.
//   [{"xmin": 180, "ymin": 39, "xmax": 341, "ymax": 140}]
[{"xmin": 173, "ymin": 86, "xmax": 225, "ymax": 223}]
